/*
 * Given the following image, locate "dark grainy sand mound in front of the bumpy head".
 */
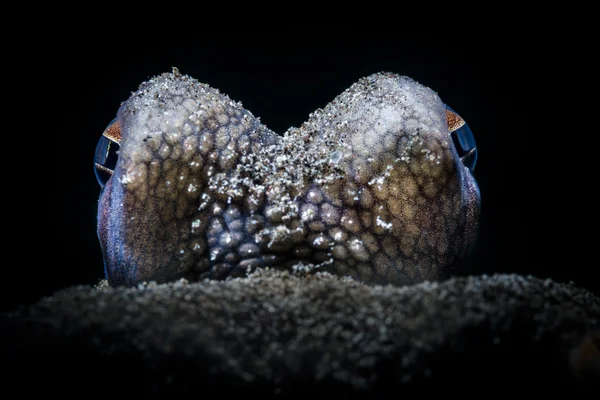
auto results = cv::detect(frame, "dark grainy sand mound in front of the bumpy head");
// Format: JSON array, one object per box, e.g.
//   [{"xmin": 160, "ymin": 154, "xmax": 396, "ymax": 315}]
[{"xmin": 0, "ymin": 270, "xmax": 600, "ymax": 398}]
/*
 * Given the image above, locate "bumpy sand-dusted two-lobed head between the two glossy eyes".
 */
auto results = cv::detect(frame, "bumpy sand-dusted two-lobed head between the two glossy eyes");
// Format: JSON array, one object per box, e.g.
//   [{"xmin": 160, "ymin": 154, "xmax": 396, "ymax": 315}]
[{"xmin": 98, "ymin": 70, "xmax": 479, "ymax": 286}]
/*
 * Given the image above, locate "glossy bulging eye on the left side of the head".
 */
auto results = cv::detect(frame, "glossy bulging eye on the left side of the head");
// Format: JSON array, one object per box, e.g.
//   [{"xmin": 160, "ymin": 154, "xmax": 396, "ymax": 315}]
[{"xmin": 94, "ymin": 118, "xmax": 121, "ymax": 187}]
